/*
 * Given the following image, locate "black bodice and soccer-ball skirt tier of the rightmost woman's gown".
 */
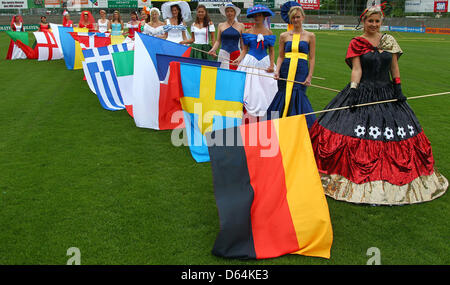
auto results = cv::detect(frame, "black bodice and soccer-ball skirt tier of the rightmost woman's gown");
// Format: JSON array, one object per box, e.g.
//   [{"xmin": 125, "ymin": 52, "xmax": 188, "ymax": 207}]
[{"xmin": 318, "ymin": 50, "xmax": 422, "ymax": 141}]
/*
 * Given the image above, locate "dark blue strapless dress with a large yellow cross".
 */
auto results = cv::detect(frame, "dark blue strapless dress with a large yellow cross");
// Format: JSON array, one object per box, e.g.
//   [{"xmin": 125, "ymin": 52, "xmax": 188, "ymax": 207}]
[{"xmin": 267, "ymin": 34, "xmax": 316, "ymax": 128}]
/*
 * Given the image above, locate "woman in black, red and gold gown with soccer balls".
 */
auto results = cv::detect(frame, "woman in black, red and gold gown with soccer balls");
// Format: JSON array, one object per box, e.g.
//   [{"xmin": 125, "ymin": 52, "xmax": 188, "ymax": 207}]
[{"xmin": 310, "ymin": 8, "xmax": 448, "ymax": 205}]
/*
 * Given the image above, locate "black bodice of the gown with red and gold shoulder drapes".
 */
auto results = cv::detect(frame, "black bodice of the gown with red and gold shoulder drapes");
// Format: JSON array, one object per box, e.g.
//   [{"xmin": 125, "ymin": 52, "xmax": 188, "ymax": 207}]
[{"xmin": 360, "ymin": 50, "xmax": 392, "ymax": 84}]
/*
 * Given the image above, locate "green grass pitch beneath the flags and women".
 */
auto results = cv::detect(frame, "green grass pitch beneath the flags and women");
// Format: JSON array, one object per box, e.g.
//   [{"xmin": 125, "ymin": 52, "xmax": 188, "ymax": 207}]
[{"xmin": 0, "ymin": 31, "xmax": 450, "ymax": 265}]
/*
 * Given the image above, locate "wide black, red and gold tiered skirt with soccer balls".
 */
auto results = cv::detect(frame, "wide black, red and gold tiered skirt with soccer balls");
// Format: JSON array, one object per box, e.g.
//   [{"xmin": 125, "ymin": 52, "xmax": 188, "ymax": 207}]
[{"xmin": 310, "ymin": 82, "xmax": 448, "ymax": 205}]
